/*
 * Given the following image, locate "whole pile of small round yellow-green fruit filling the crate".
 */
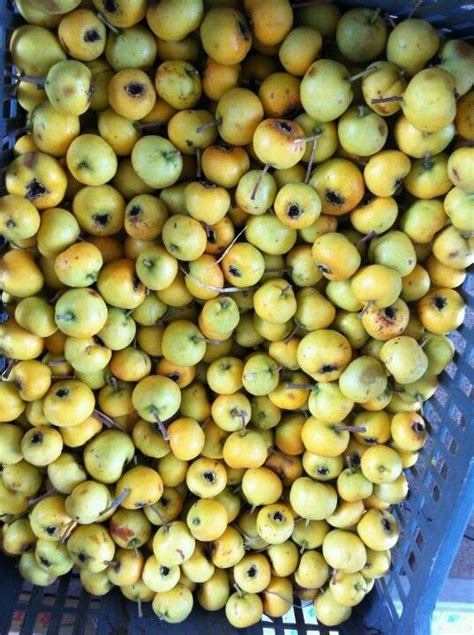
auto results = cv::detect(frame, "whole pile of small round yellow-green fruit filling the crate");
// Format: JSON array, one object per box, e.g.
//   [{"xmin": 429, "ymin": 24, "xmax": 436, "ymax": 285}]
[{"xmin": 0, "ymin": 0, "xmax": 474, "ymax": 627}]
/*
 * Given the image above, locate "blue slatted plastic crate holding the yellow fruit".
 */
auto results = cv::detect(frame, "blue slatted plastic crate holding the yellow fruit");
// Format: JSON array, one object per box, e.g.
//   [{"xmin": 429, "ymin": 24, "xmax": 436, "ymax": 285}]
[{"xmin": 0, "ymin": 0, "xmax": 474, "ymax": 635}]
